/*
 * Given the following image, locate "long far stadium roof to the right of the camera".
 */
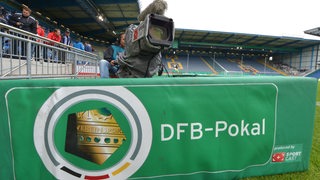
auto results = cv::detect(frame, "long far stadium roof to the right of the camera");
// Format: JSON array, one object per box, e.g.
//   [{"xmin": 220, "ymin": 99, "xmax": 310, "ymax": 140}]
[{"xmin": 175, "ymin": 29, "xmax": 320, "ymax": 53}]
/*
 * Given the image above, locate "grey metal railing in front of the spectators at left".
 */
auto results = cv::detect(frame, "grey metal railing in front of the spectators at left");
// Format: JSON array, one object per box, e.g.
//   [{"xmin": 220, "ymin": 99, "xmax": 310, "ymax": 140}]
[{"xmin": 0, "ymin": 23, "xmax": 99, "ymax": 80}]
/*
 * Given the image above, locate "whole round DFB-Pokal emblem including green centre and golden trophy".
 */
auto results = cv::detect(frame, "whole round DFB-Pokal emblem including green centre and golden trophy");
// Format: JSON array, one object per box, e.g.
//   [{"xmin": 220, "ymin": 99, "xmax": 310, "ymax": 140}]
[{"xmin": 34, "ymin": 86, "xmax": 152, "ymax": 179}]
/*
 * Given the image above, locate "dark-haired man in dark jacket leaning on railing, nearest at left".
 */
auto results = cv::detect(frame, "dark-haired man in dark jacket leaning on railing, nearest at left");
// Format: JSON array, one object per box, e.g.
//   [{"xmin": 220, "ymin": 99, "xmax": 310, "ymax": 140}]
[{"xmin": 9, "ymin": 5, "xmax": 37, "ymax": 56}]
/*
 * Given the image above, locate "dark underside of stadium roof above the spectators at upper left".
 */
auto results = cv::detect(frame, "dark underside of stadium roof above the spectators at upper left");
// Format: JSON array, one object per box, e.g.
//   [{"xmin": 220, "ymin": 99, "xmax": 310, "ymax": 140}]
[{"xmin": 11, "ymin": 0, "xmax": 140, "ymax": 42}]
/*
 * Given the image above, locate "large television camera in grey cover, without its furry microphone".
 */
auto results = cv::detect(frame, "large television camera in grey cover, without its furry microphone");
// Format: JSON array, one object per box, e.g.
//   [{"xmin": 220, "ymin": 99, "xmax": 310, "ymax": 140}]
[{"xmin": 118, "ymin": 14, "xmax": 175, "ymax": 78}]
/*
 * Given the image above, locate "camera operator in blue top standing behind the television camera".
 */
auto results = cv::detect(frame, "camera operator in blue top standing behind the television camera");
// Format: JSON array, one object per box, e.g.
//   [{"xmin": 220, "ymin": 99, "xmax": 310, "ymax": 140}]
[{"xmin": 99, "ymin": 33, "xmax": 125, "ymax": 78}]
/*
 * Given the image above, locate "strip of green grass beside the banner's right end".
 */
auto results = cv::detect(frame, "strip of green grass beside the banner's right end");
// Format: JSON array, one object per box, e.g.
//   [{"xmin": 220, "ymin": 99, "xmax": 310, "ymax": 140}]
[{"xmin": 243, "ymin": 83, "xmax": 320, "ymax": 180}]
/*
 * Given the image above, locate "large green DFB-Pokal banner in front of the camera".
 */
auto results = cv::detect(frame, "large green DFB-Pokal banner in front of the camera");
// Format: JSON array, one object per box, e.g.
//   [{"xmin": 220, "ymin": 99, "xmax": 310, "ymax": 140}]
[{"xmin": 0, "ymin": 78, "xmax": 316, "ymax": 179}]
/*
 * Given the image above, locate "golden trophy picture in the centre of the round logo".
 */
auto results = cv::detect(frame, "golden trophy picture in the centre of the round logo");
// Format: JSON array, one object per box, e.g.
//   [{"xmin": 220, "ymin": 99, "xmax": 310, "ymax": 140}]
[{"xmin": 65, "ymin": 108, "xmax": 126, "ymax": 164}]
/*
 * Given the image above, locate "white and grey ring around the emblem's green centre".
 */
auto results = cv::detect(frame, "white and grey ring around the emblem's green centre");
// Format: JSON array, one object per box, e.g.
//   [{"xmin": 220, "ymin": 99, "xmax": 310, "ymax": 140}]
[{"xmin": 34, "ymin": 86, "xmax": 152, "ymax": 180}]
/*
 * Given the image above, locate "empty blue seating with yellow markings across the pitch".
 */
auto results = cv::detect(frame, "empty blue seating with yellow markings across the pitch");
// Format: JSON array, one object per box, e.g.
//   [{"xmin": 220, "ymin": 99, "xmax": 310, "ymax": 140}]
[{"xmin": 163, "ymin": 55, "xmax": 281, "ymax": 76}]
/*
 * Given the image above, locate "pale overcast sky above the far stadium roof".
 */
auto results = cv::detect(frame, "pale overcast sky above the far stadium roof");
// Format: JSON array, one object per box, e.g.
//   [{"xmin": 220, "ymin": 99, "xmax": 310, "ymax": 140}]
[{"xmin": 140, "ymin": 0, "xmax": 320, "ymax": 39}]
